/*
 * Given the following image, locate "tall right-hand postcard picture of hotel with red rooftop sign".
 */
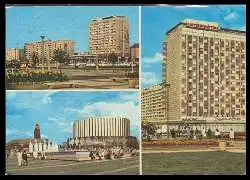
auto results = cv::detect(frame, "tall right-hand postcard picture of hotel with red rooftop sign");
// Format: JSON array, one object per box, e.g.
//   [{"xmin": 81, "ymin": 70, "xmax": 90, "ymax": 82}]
[{"xmin": 141, "ymin": 5, "xmax": 246, "ymax": 174}]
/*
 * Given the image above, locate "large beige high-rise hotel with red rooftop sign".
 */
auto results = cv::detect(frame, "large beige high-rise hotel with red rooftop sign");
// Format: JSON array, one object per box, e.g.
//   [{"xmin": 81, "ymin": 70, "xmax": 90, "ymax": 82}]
[{"xmin": 163, "ymin": 19, "xmax": 246, "ymax": 130}]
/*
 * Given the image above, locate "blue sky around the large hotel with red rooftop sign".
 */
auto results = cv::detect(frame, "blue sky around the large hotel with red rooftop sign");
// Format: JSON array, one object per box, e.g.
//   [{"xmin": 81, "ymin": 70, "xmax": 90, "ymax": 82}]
[{"xmin": 141, "ymin": 5, "xmax": 246, "ymax": 87}]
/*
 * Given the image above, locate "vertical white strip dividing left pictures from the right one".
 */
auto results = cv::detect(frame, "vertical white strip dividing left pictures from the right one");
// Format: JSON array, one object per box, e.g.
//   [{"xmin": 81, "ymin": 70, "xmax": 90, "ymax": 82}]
[{"xmin": 138, "ymin": 6, "xmax": 142, "ymax": 175}]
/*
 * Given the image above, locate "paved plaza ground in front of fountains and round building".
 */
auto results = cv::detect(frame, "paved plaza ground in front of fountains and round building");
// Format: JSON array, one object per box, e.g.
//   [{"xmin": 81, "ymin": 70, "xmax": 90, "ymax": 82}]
[{"xmin": 6, "ymin": 157, "xmax": 140, "ymax": 175}]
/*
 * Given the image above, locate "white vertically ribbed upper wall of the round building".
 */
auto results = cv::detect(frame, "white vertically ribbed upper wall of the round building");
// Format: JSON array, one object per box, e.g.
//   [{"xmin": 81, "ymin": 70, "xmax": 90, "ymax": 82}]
[{"xmin": 73, "ymin": 117, "xmax": 130, "ymax": 138}]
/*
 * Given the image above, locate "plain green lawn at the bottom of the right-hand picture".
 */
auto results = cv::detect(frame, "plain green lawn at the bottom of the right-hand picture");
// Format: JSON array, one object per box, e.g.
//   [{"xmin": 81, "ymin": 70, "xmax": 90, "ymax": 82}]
[{"xmin": 142, "ymin": 152, "xmax": 246, "ymax": 174}]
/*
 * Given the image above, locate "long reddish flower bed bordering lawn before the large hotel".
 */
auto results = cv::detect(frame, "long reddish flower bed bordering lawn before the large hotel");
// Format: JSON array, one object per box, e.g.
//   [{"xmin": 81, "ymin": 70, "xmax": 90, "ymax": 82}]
[{"xmin": 142, "ymin": 139, "xmax": 219, "ymax": 146}]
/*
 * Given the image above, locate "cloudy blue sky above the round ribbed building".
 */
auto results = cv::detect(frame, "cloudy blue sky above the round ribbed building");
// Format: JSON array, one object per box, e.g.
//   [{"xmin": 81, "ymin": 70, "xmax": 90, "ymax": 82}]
[{"xmin": 6, "ymin": 91, "xmax": 140, "ymax": 143}]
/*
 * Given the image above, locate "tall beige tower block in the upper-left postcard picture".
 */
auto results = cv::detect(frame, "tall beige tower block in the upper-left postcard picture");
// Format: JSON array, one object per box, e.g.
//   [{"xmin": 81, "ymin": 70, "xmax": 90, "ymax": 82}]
[{"xmin": 89, "ymin": 16, "xmax": 129, "ymax": 57}]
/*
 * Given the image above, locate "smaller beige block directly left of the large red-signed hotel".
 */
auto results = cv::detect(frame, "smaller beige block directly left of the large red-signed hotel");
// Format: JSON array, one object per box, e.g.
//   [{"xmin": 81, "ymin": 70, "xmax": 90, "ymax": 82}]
[{"xmin": 141, "ymin": 84, "xmax": 166, "ymax": 122}]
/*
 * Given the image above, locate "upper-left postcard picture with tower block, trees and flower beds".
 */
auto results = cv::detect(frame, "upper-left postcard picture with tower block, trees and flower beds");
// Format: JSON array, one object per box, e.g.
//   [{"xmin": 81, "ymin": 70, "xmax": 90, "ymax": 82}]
[{"xmin": 5, "ymin": 6, "xmax": 140, "ymax": 90}]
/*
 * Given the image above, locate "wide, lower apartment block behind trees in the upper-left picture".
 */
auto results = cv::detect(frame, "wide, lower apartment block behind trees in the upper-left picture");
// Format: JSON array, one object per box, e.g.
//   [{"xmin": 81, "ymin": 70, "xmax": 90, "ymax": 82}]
[{"xmin": 24, "ymin": 40, "xmax": 75, "ymax": 62}]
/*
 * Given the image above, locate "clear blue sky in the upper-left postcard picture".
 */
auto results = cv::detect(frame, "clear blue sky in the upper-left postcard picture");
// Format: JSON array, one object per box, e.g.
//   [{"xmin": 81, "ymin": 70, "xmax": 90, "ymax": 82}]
[{"xmin": 6, "ymin": 6, "xmax": 139, "ymax": 51}]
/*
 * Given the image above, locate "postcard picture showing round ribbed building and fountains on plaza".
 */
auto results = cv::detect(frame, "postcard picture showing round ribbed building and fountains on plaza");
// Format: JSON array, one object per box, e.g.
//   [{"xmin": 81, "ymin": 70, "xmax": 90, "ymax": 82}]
[{"xmin": 6, "ymin": 91, "xmax": 140, "ymax": 175}]
